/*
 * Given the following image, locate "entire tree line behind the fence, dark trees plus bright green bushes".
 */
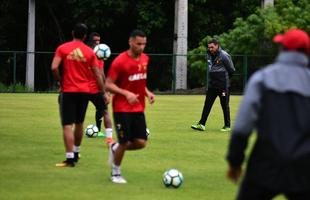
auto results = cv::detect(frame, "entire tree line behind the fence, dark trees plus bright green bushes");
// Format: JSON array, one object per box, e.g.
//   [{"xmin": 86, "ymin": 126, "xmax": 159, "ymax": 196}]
[{"xmin": 0, "ymin": 0, "xmax": 310, "ymax": 88}]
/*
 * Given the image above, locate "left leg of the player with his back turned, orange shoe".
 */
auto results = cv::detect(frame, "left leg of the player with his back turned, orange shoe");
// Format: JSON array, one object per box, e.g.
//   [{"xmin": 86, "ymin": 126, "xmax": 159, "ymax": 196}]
[{"xmin": 56, "ymin": 93, "xmax": 76, "ymax": 167}]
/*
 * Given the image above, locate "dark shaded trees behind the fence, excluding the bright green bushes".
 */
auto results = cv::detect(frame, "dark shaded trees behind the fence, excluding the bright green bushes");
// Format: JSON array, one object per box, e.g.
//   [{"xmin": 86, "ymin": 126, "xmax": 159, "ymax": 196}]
[{"xmin": 0, "ymin": 0, "xmax": 260, "ymax": 90}]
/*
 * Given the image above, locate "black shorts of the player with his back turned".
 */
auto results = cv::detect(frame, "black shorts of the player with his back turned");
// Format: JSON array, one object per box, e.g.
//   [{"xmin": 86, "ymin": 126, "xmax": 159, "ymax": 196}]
[{"xmin": 58, "ymin": 92, "xmax": 89, "ymax": 125}]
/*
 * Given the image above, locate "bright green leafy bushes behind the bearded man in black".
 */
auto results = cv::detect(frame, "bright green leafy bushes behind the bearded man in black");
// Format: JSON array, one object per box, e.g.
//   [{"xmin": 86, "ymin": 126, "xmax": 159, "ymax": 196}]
[{"xmin": 189, "ymin": 0, "xmax": 310, "ymax": 88}]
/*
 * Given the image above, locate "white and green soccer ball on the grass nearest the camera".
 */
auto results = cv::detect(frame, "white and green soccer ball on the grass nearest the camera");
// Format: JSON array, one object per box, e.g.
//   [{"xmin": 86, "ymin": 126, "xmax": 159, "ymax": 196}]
[{"xmin": 163, "ymin": 169, "xmax": 184, "ymax": 188}]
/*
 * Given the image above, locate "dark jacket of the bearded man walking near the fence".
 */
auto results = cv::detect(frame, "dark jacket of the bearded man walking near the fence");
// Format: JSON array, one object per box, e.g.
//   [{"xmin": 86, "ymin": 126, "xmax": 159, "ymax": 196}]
[{"xmin": 207, "ymin": 48, "xmax": 235, "ymax": 89}]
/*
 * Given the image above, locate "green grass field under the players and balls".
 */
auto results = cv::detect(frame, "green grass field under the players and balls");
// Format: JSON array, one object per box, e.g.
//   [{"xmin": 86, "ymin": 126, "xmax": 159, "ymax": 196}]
[{"xmin": 0, "ymin": 94, "xmax": 284, "ymax": 200}]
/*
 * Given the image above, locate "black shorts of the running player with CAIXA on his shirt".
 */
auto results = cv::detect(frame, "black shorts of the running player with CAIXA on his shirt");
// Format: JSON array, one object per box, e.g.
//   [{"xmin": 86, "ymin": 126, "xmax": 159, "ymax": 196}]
[{"xmin": 113, "ymin": 112, "xmax": 147, "ymax": 144}]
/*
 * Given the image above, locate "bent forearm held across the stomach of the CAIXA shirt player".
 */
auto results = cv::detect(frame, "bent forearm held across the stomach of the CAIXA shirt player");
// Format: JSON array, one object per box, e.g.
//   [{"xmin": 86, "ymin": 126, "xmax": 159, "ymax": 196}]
[{"xmin": 106, "ymin": 77, "xmax": 139, "ymax": 104}]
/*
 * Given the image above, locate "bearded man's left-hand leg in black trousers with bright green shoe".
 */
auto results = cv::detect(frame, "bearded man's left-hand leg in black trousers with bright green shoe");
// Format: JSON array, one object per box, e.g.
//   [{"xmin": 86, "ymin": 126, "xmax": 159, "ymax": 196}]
[{"xmin": 191, "ymin": 88, "xmax": 217, "ymax": 131}]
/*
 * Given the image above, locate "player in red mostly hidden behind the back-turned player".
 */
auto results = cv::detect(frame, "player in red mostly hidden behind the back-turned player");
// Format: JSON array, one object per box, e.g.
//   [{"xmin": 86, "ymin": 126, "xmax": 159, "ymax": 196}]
[{"xmin": 88, "ymin": 32, "xmax": 113, "ymax": 145}]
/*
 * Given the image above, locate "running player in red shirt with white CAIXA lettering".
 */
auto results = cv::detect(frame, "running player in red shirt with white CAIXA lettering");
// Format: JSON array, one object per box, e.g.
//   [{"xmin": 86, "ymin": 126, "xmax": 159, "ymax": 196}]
[{"xmin": 106, "ymin": 30, "xmax": 155, "ymax": 183}]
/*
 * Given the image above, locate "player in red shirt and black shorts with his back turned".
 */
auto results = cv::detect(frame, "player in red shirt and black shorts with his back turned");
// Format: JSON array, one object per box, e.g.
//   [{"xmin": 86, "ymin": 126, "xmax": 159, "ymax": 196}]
[{"xmin": 51, "ymin": 23, "xmax": 104, "ymax": 167}]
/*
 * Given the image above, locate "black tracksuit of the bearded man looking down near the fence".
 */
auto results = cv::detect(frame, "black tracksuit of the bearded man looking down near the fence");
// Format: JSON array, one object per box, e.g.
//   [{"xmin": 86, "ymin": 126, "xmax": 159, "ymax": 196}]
[{"xmin": 199, "ymin": 48, "xmax": 235, "ymax": 127}]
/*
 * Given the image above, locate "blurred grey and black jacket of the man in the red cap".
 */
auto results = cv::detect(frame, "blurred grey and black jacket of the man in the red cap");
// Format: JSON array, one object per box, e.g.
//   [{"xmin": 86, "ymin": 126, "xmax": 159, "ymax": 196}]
[{"xmin": 227, "ymin": 51, "xmax": 310, "ymax": 192}]
